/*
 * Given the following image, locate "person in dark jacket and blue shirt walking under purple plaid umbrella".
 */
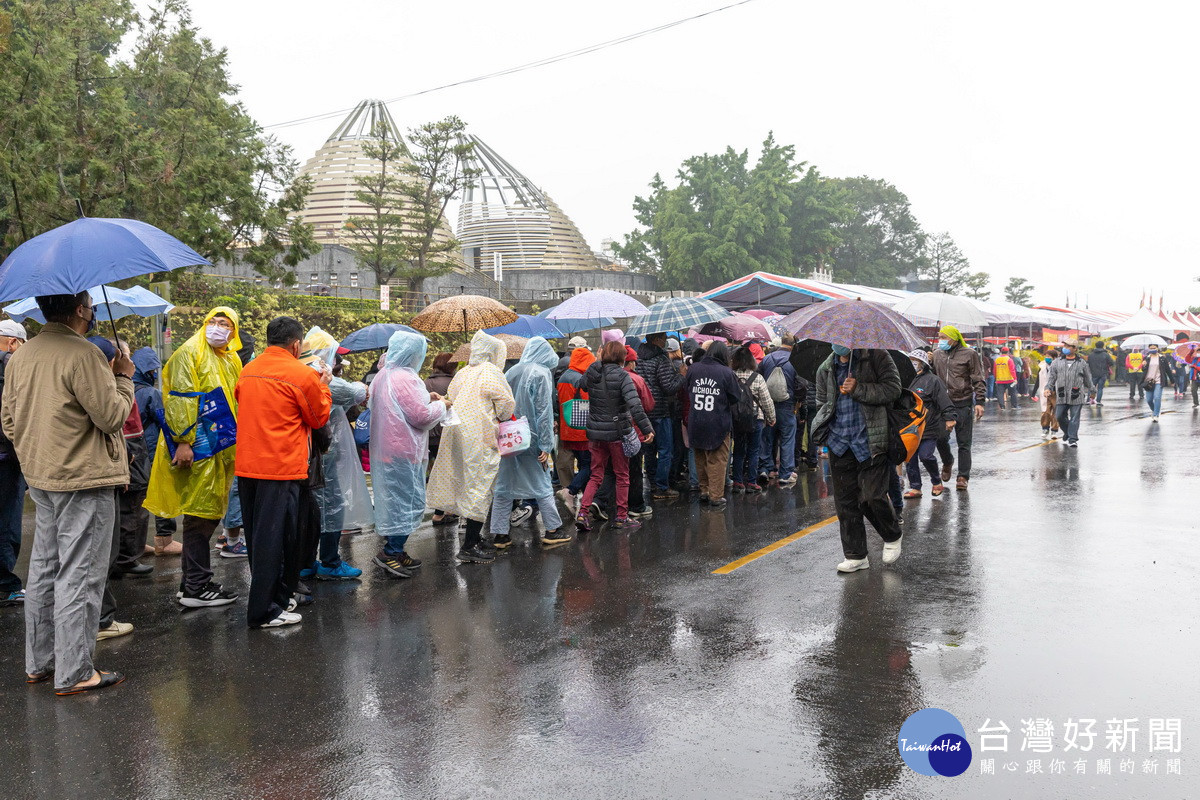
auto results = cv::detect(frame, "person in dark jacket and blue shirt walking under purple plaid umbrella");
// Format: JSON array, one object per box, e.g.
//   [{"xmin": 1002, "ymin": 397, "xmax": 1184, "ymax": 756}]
[{"xmin": 812, "ymin": 344, "xmax": 902, "ymax": 572}]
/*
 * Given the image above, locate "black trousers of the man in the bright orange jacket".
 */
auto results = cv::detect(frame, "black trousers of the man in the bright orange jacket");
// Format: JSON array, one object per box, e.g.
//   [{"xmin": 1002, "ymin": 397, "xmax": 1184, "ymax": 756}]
[{"xmin": 238, "ymin": 477, "xmax": 298, "ymax": 627}]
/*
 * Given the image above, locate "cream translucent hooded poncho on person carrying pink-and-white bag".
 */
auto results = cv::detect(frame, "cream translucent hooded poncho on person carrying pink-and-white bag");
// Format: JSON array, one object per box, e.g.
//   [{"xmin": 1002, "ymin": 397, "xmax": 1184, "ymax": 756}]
[{"xmin": 426, "ymin": 331, "xmax": 516, "ymax": 522}]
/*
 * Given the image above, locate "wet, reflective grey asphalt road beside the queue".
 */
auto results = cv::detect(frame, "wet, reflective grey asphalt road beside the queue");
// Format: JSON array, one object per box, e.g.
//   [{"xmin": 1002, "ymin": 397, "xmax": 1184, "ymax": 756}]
[{"xmin": 0, "ymin": 390, "xmax": 1200, "ymax": 799}]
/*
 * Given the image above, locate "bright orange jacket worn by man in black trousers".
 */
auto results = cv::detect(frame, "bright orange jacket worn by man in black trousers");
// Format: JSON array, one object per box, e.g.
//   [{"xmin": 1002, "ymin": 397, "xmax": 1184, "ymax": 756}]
[{"xmin": 234, "ymin": 345, "xmax": 332, "ymax": 481}]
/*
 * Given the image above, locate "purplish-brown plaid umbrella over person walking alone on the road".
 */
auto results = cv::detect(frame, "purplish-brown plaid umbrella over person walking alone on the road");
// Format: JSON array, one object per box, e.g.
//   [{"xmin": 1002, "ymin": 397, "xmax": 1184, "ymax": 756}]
[{"xmin": 780, "ymin": 300, "xmax": 929, "ymax": 353}]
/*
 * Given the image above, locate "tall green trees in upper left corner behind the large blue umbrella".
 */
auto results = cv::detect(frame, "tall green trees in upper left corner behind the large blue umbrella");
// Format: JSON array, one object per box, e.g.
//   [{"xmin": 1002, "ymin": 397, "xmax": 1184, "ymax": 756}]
[{"xmin": 0, "ymin": 0, "xmax": 318, "ymax": 272}]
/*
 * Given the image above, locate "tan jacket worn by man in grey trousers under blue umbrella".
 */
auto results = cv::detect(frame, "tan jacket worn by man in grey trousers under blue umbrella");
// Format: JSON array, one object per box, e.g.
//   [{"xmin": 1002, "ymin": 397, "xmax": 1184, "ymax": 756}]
[{"xmin": 0, "ymin": 323, "xmax": 133, "ymax": 492}]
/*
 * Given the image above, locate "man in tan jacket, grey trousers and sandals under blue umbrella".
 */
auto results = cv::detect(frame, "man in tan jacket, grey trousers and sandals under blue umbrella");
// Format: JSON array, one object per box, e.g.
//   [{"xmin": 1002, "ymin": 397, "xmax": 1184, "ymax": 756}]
[{"xmin": 0, "ymin": 291, "xmax": 133, "ymax": 696}]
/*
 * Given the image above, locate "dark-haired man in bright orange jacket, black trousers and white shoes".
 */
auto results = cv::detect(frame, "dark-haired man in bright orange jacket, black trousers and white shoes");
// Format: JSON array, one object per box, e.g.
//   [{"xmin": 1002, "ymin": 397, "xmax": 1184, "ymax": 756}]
[{"xmin": 234, "ymin": 317, "xmax": 332, "ymax": 627}]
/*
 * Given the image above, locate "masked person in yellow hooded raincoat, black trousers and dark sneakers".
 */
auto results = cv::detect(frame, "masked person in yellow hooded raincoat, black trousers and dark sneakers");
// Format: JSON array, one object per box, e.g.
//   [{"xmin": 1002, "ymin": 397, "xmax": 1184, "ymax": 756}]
[{"xmin": 144, "ymin": 306, "xmax": 241, "ymax": 608}]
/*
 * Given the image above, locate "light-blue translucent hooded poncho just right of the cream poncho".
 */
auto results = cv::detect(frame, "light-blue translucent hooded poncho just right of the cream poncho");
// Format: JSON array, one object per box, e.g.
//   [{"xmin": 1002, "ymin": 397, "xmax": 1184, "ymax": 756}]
[{"xmin": 496, "ymin": 336, "xmax": 558, "ymax": 500}]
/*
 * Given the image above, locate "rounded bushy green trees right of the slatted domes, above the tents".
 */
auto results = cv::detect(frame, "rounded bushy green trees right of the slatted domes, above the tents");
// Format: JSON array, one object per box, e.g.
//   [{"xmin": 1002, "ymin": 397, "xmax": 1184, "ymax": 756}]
[{"xmin": 613, "ymin": 134, "xmax": 846, "ymax": 288}]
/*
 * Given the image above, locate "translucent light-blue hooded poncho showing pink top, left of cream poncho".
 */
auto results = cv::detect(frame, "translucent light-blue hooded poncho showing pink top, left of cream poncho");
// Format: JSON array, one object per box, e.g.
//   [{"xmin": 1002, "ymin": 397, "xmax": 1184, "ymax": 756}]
[{"xmin": 368, "ymin": 331, "xmax": 446, "ymax": 536}]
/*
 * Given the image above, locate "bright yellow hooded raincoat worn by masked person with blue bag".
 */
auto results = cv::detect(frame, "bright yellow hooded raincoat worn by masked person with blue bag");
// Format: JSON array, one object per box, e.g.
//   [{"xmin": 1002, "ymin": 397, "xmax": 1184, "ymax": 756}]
[{"xmin": 143, "ymin": 306, "xmax": 241, "ymax": 519}]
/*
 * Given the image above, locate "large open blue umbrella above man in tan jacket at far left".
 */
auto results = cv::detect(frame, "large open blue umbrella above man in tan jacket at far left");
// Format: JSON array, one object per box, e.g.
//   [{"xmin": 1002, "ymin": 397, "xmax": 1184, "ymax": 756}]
[{"xmin": 0, "ymin": 217, "xmax": 209, "ymax": 302}]
